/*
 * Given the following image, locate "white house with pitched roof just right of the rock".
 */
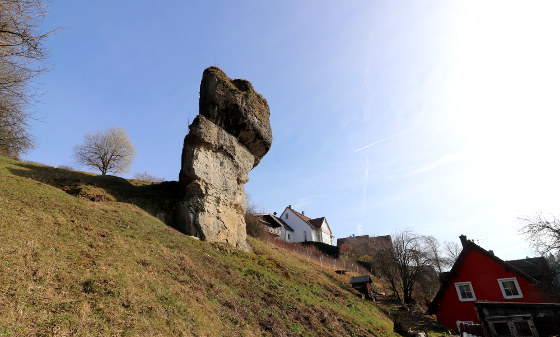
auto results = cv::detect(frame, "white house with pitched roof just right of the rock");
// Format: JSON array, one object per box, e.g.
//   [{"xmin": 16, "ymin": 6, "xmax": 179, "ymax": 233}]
[{"xmin": 280, "ymin": 205, "xmax": 333, "ymax": 245}]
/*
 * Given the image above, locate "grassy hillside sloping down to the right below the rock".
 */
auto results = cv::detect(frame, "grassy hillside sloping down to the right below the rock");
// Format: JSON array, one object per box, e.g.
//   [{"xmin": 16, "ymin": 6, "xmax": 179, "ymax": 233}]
[{"xmin": 0, "ymin": 157, "xmax": 394, "ymax": 336}]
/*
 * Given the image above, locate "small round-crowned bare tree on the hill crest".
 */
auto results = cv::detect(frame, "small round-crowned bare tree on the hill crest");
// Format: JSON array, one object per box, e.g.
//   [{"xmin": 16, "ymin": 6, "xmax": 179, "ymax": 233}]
[{"xmin": 74, "ymin": 128, "xmax": 135, "ymax": 175}]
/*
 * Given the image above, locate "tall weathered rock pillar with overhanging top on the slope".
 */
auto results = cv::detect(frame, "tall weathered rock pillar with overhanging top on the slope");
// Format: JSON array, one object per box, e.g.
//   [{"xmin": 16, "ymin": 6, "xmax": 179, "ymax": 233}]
[{"xmin": 177, "ymin": 67, "xmax": 272, "ymax": 250}]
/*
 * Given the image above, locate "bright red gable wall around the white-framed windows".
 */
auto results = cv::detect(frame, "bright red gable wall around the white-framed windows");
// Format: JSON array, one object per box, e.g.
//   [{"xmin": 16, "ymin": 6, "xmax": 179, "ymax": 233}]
[{"xmin": 436, "ymin": 249, "xmax": 547, "ymax": 330}]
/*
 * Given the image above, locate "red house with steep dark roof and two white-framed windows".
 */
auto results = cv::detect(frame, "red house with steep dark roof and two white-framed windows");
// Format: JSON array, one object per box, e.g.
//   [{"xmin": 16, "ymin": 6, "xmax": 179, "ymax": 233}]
[{"xmin": 428, "ymin": 235, "xmax": 557, "ymax": 330}]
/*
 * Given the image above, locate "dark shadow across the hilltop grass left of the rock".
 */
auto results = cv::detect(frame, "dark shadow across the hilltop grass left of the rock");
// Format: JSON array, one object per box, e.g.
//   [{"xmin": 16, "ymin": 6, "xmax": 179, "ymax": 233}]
[{"xmin": 8, "ymin": 162, "xmax": 182, "ymax": 226}]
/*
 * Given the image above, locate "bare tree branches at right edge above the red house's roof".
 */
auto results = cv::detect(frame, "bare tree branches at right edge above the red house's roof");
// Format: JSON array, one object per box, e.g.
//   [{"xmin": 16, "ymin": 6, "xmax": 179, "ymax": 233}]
[{"xmin": 520, "ymin": 213, "xmax": 560, "ymax": 255}]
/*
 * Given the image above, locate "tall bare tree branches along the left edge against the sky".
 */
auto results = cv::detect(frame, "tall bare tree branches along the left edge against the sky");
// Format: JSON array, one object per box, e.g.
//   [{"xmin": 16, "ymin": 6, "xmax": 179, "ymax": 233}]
[{"xmin": 0, "ymin": 0, "xmax": 52, "ymax": 157}]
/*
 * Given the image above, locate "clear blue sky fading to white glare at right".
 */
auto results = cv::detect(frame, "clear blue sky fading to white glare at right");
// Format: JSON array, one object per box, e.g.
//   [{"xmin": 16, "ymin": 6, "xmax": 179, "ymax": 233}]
[{"xmin": 29, "ymin": 0, "xmax": 560, "ymax": 258}]
